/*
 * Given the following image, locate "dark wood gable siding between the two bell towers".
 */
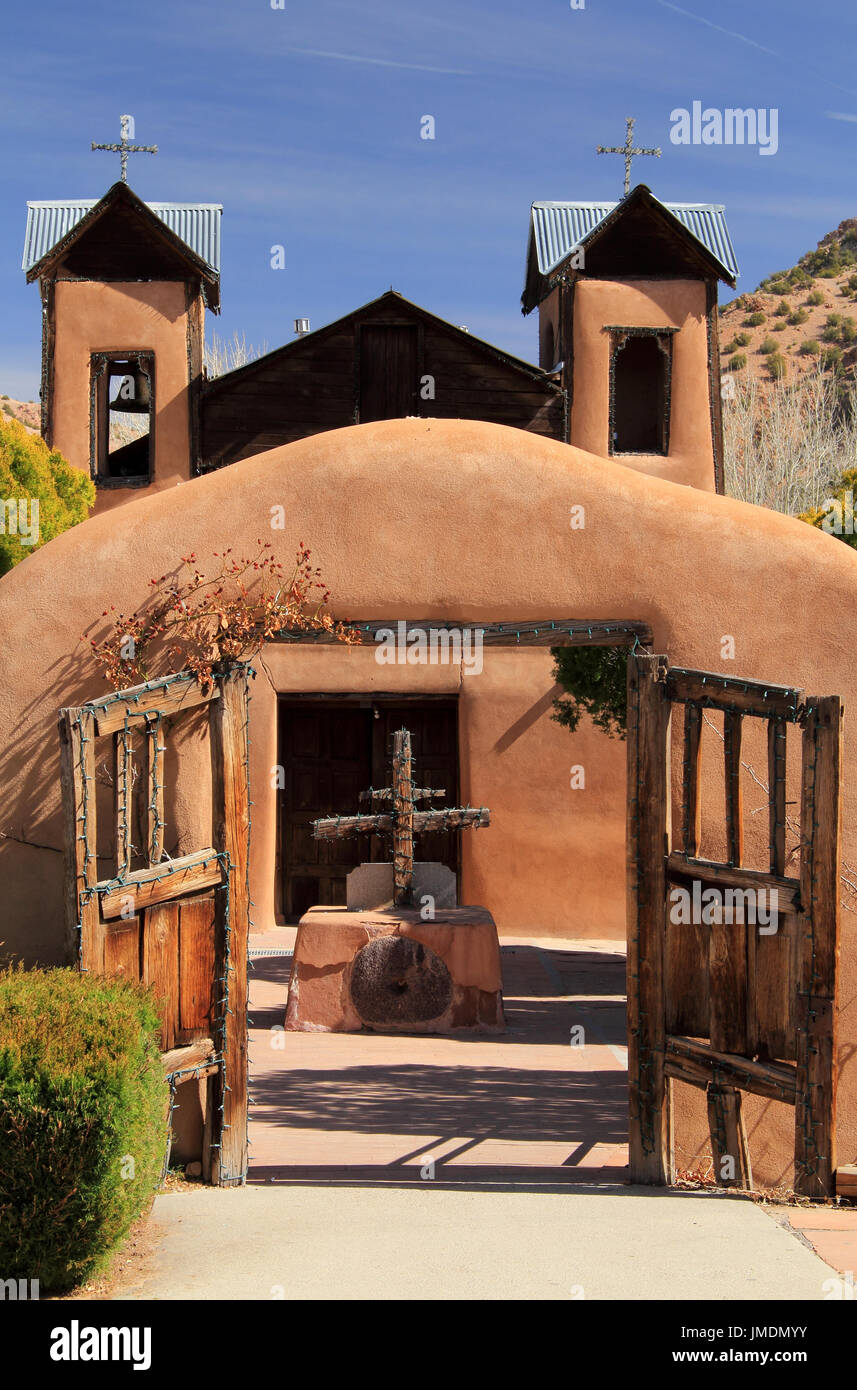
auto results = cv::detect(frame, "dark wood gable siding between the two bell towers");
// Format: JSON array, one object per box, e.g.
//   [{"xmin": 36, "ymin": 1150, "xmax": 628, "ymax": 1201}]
[{"xmin": 201, "ymin": 295, "xmax": 565, "ymax": 468}]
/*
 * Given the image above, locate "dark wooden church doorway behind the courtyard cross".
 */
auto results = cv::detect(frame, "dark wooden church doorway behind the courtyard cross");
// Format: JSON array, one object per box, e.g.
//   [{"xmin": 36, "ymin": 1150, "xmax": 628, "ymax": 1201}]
[{"xmin": 276, "ymin": 695, "xmax": 460, "ymax": 923}]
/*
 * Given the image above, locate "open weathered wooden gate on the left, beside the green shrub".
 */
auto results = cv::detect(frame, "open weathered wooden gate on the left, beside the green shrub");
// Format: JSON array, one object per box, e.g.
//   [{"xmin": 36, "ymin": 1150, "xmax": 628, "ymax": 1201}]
[{"xmin": 60, "ymin": 663, "xmax": 251, "ymax": 1184}]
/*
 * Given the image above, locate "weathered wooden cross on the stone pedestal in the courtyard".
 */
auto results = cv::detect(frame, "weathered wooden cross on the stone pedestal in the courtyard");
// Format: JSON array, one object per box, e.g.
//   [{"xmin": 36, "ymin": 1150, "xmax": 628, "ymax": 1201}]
[{"xmin": 313, "ymin": 728, "xmax": 490, "ymax": 908}]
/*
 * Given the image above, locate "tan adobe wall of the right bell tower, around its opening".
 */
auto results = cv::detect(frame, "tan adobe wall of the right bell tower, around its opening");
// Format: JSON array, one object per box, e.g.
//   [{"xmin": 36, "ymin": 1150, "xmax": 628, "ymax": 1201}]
[{"xmin": 569, "ymin": 279, "xmax": 719, "ymax": 492}]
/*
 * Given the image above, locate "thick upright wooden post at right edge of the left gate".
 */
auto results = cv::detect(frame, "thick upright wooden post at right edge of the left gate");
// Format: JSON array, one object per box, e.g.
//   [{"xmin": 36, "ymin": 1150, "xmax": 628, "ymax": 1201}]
[{"xmin": 208, "ymin": 666, "xmax": 250, "ymax": 1186}]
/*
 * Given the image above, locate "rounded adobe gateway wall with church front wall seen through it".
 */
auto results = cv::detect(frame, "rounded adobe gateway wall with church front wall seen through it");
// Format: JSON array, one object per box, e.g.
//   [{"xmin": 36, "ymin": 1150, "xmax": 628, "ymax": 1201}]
[{"xmin": 0, "ymin": 420, "xmax": 857, "ymax": 1183}]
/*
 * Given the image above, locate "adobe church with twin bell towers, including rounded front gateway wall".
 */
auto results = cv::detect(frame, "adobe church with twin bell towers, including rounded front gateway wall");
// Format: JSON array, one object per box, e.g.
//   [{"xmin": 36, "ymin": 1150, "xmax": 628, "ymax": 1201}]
[{"xmin": 0, "ymin": 127, "xmax": 857, "ymax": 1183}]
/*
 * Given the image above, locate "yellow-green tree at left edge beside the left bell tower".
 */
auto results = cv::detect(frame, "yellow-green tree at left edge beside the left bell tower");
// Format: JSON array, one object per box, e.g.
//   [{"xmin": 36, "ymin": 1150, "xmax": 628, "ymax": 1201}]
[{"xmin": 0, "ymin": 417, "xmax": 96, "ymax": 574}]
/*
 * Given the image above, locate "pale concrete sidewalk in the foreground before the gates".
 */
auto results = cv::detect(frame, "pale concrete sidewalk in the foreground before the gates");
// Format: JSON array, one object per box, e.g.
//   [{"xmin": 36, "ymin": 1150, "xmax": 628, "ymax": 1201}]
[{"xmin": 113, "ymin": 1180, "xmax": 836, "ymax": 1301}]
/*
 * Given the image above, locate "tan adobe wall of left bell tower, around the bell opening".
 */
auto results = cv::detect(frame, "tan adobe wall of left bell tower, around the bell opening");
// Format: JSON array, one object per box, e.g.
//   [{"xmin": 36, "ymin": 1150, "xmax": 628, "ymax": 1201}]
[{"xmin": 51, "ymin": 279, "xmax": 201, "ymax": 514}]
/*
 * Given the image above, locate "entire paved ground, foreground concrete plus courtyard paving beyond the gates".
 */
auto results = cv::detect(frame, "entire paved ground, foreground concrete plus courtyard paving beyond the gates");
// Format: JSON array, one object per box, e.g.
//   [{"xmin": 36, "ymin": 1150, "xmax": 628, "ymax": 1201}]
[{"xmin": 114, "ymin": 930, "xmax": 857, "ymax": 1301}]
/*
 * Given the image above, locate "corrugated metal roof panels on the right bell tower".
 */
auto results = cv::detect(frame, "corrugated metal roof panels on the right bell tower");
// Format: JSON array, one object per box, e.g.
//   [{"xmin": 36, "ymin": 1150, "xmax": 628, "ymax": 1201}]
[{"xmin": 532, "ymin": 203, "xmax": 738, "ymax": 277}]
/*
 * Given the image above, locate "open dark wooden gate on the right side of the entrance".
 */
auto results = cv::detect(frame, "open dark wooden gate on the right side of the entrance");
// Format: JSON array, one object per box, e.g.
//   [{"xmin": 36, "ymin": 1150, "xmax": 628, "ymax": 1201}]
[{"xmin": 628, "ymin": 653, "xmax": 842, "ymax": 1198}]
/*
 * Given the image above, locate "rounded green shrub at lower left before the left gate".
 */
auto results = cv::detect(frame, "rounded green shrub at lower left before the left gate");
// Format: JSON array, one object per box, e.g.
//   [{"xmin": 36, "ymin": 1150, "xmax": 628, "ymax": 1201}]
[{"xmin": 0, "ymin": 969, "xmax": 168, "ymax": 1291}]
